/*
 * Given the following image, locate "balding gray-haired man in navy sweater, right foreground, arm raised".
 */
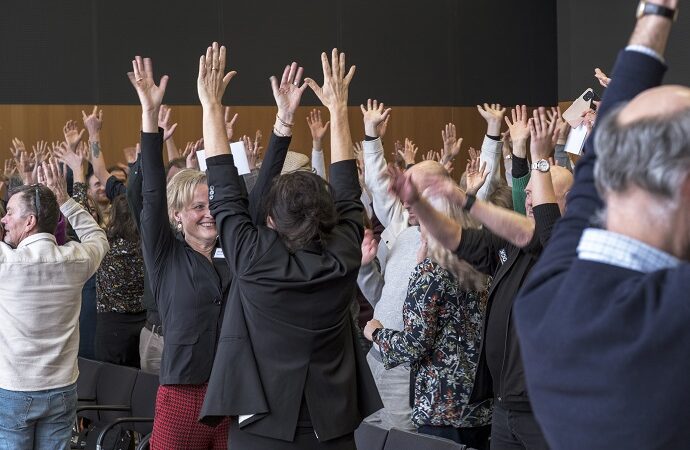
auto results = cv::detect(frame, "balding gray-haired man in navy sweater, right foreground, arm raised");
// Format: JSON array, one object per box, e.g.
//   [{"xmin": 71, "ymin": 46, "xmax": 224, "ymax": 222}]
[{"xmin": 515, "ymin": 0, "xmax": 690, "ymax": 450}]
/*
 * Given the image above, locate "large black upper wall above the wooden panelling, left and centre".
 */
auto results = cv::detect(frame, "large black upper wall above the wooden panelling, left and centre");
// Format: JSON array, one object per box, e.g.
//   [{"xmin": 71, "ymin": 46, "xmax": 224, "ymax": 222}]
[{"xmin": 0, "ymin": 0, "xmax": 557, "ymax": 106}]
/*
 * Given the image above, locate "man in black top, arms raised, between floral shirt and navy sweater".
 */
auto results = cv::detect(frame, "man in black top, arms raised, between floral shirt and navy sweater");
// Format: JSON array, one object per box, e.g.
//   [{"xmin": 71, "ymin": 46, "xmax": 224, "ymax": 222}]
[{"xmin": 394, "ymin": 108, "xmax": 573, "ymax": 449}]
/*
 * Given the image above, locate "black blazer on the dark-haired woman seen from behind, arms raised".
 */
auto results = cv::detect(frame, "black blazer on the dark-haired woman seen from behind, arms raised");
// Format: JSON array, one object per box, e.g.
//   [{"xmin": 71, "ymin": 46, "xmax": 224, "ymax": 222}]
[{"xmin": 201, "ymin": 155, "xmax": 383, "ymax": 441}]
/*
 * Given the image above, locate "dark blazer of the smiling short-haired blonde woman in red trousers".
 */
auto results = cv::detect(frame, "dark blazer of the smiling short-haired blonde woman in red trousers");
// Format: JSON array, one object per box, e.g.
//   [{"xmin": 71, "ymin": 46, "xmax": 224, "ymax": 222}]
[{"xmin": 135, "ymin": 129, "xmax": 290, "ymax": 384}]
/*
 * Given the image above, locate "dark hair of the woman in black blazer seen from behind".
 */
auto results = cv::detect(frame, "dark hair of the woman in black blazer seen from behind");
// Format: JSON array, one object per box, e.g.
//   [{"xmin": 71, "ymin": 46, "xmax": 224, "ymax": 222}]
[{"xmin": 264, "ymin": 171, "xmax": 338, "ymax": 252}]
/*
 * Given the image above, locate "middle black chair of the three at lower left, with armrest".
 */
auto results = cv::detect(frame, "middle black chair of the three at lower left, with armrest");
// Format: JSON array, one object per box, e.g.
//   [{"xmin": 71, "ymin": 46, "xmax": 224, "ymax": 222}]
[{"xmin": 73, "ymin": 363, "xmax": 139, "ymax": 449}]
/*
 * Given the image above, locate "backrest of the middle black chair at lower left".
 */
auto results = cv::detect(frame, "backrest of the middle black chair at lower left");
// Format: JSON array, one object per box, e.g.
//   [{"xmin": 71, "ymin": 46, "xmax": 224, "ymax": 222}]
[{"xmin": 96, "ymin": 363, "xmax": 139, "ymax": 422}]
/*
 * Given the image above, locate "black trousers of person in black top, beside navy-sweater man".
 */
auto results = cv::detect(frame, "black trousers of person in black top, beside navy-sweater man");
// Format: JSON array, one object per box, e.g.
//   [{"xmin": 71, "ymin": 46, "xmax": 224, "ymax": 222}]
[{"xmin": 491, "ymin": 401, "xmax": 549, "ymax": 450}]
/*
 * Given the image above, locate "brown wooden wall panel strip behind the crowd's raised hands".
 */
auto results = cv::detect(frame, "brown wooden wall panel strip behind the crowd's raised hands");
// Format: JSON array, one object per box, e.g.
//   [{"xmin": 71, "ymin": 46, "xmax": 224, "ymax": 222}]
[{"xmin": 0, "ymin": 105, "xmax": 494, "ymax": 181}]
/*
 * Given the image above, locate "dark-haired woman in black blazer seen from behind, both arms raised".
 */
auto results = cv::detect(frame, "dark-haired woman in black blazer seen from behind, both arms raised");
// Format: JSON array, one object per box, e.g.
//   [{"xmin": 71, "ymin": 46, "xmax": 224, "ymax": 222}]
[{"xmin": 198, "ymin": 43, "xmax": 382, "ymax": 450}]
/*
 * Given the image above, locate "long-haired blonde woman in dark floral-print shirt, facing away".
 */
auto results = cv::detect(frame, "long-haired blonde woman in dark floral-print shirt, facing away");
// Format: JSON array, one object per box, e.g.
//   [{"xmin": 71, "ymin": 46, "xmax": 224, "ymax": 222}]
[{"xmin": 364, "ymin": 185, "xmax": 492, "ymax": 449}]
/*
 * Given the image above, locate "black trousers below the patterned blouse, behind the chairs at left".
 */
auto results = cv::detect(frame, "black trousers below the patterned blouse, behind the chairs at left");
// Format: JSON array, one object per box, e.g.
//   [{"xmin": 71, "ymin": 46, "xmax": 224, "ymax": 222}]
[{"xmin": 96, "ymin": 312, "xmax": 146, "ymax": 368}]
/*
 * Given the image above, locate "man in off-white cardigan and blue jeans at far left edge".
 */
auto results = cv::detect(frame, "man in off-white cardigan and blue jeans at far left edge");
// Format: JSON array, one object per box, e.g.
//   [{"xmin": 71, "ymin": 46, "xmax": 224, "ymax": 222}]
[{"xmin": 0, "ymin": 160, "xmax": 108, "ymax": 450}]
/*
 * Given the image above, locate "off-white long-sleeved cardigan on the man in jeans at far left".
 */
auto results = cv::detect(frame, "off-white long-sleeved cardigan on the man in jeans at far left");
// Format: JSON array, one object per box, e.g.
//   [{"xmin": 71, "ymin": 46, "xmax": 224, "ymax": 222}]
[{"xmin": 0, "ymin": 199, "xmax": 109, "ymax": 391}]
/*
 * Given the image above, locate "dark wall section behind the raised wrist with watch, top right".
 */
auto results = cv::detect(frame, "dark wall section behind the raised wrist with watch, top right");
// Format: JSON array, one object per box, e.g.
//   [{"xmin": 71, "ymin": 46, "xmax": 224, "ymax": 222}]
[{"xmin": 558, "ymin": 0, "xmax": 690, "ymax": 100}]
